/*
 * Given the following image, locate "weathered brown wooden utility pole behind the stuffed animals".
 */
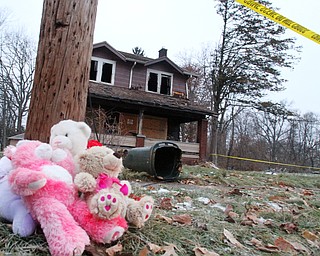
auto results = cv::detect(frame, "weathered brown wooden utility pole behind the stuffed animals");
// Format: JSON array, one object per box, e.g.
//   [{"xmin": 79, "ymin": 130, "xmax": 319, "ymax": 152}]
[{"xmin": 25, "ymin": 0, "xmax": 98, "ymax": 142}]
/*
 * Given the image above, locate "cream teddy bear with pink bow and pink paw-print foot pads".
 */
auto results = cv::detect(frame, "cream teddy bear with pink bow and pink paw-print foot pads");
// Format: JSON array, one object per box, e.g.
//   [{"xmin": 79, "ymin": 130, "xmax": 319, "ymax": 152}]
[{"xmin": 74, "ymin": 145, "xmax": 154, "ymax": 228}]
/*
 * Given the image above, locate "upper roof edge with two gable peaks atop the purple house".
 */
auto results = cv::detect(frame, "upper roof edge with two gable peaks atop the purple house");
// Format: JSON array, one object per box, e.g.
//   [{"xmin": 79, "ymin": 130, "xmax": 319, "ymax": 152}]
[{"xmin": 93, "ymin": 41, "xmax": 198, "ymax": 77}]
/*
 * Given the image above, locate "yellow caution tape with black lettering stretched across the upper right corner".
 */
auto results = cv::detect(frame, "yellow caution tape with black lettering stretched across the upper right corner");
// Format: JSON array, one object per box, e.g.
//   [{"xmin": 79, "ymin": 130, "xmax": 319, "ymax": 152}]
[{"xmin": 235, "ymin": 0, "xmax": 320, "ymax": 44}]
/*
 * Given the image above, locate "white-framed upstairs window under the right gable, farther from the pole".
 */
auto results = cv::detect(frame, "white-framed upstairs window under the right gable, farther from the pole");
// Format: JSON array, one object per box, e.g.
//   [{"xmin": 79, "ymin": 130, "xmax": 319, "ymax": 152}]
[{"xmin": 147, "ymin": 70, "xmax": 172, "ymax": 95}]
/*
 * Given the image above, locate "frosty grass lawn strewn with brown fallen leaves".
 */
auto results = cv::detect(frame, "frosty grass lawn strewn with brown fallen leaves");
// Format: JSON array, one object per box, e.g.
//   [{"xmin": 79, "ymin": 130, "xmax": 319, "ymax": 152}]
[{"xmin": 0, "ymin": 166, "xmax": 320, "ymax": 255}]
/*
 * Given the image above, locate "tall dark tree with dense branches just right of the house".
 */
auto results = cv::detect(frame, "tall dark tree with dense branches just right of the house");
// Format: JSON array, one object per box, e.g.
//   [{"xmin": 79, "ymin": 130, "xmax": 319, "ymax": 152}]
[{"xmin": 204, "ymin": 0, "xmax": 299, "ymax": 164}]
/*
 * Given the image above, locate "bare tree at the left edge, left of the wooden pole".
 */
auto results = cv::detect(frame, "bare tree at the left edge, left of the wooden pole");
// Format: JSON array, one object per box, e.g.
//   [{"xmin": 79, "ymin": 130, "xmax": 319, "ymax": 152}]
[{"xmin": 0, "ymin": 29, "xmax": 36, "ymax": 150}]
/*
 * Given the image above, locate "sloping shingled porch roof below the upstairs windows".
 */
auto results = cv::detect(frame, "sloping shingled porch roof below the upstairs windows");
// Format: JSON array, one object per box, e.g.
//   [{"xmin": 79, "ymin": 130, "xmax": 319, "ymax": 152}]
[{"xmin": 89, "ymin": 81, "xmax": 213, "ymax": 121}]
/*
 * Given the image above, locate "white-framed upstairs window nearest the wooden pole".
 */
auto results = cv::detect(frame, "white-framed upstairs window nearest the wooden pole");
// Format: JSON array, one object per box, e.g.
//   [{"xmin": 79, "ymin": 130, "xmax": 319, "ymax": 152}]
[{"xmin": 90, "ymin": 57, "xmax": 116, "ymax": 85}]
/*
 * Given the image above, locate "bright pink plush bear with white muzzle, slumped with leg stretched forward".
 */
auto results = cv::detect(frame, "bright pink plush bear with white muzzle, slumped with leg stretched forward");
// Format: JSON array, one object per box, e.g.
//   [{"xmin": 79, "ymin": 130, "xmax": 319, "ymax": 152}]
[{"xmin": 9, "ymin": 141, "xmax": 90, "ymax": 256}]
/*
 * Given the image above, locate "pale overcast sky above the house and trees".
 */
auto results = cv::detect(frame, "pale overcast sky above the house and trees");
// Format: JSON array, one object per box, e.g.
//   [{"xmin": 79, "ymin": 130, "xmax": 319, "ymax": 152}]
[{"xmin": 0, "ymin": 0, "xmax": 320, "ymax": 114}]
